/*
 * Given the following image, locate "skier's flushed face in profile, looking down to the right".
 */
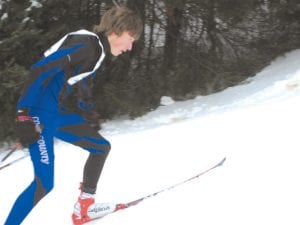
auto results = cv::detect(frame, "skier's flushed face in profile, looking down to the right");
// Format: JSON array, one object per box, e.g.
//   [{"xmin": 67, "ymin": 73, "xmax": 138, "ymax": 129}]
[{"xmin": 108, "ymin": 32, "xmax": 135, "ymax": 56}]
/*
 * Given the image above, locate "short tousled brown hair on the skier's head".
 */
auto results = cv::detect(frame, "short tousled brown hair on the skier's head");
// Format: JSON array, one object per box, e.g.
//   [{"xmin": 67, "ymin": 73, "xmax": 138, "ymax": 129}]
[{"xmin": 93, "ymin": 6, "xmax": 143, "ymax": 40}]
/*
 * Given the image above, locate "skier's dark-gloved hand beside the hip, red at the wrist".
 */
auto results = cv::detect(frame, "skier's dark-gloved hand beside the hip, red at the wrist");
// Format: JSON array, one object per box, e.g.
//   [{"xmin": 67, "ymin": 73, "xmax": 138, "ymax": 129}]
[{"xmin": 15, "ymin": 110, "xmax": 40, "ymax": 147}]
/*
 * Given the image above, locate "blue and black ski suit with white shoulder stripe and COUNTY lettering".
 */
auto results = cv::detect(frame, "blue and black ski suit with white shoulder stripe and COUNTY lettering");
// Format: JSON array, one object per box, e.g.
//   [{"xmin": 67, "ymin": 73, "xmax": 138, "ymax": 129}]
[{"xmin": 5, "ymin": 30, "xmax": 111, "ymax": 225}]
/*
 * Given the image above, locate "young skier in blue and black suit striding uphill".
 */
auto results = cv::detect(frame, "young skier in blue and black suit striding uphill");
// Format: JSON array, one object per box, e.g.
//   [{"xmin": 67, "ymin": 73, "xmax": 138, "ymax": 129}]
[{"xmin": 5, "ymin": 6, "xmax": 143, "ymax": 225}]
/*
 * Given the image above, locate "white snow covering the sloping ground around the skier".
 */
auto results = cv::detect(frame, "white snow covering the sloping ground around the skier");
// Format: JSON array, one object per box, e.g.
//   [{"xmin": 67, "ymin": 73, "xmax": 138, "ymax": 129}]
[{"xmin": 0, "ymin": 50, "xmax": 300, "ymax": 225}]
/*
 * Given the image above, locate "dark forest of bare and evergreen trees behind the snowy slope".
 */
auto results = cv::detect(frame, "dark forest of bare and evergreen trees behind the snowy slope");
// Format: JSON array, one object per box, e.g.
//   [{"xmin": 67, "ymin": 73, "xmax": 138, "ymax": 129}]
[{"xmin": 0, "ymin": 0, "xmax": 300, "ymax": 142}]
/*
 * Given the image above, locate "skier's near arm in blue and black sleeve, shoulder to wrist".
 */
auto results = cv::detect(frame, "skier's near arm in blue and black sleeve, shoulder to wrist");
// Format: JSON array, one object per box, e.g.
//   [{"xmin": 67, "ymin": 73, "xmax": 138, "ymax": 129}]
[{"xmin": 17, "ymin": 35, "xmax": 100, "ymax": 109}]
